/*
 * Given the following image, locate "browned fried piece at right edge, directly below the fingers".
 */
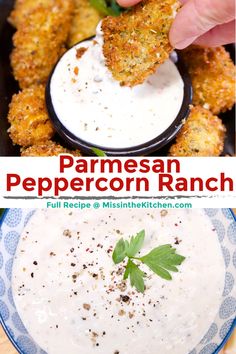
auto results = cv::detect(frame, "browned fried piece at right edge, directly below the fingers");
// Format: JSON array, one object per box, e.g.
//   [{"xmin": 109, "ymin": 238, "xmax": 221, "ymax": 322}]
[{"xmin": 180, "ymin": 46, "xmax": 235, "ymax": 114}]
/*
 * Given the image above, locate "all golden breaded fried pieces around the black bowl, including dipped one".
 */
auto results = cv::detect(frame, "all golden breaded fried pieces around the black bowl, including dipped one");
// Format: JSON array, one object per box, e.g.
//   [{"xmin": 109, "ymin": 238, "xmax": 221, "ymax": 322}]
[{"xmin": 8, "ymin": 0, "xmax": 235, "ymax": 156}]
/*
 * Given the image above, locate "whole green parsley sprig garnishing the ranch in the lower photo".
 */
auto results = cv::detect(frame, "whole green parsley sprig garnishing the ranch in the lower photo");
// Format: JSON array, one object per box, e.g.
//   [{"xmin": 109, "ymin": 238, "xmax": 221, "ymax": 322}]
[{"xmin": 112, "ymin": 230, "xmax": 185, "ymax": 293}]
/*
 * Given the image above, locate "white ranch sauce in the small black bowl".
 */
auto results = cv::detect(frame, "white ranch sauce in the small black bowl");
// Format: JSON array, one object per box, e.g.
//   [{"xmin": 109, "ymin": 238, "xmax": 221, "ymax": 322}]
[{"xmin": 50, "ymin": 26, "xmax": 184, "ymax": 148}]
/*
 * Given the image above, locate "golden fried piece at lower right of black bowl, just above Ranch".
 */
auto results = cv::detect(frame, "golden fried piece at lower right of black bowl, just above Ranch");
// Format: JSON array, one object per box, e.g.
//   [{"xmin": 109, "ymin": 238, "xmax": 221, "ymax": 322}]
[{"xmin": 169, "ymin": 106, "xmax": 226, "ymax": 156}]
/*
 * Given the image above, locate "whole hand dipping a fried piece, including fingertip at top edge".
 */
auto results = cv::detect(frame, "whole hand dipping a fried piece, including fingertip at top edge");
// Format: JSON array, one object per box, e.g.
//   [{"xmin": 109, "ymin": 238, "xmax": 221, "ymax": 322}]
[{"xmin": 117, "ymin": 0, "xmax": 235, "ymax": 49}]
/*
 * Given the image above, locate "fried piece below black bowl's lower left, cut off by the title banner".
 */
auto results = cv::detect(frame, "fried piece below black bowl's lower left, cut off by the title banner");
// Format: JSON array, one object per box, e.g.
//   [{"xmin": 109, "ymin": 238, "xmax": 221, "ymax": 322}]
[{"xmin": 21, "ymin": 141, "xmax": 81, "ymax": 157}]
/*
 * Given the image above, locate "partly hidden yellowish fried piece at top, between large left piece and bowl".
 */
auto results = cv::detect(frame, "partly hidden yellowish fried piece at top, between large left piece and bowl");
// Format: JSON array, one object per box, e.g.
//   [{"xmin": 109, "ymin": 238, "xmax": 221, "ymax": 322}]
[{"xmin": 68, "ymin": 0, "xmax": 102, "ymax": 47}]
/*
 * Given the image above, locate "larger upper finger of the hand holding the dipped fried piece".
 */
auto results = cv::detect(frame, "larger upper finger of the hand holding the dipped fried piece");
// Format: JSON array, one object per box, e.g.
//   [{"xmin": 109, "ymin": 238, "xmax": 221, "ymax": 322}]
[{"xmin": 170, "ymin": 0, "xmax": 235, "ymax": 49}]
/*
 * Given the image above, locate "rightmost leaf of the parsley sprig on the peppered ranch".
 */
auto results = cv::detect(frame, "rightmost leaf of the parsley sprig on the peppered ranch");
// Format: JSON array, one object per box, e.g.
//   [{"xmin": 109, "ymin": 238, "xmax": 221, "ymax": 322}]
[{"xmin": 140, "ymin": 245, "xmax": 185, "ymax": 280}]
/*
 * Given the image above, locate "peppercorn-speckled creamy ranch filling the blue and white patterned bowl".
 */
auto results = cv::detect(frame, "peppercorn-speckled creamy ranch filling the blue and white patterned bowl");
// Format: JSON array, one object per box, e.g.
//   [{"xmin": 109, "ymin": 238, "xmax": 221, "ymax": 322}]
[{"xmin": 12, "ymin": 209, "xmax": 225, "ymax": 354}]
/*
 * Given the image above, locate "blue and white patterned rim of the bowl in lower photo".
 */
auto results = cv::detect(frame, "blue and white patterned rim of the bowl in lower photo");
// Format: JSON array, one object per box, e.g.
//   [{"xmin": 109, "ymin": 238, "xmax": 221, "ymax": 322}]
[{"xmin": 0, "ymin": 209, "xmax": 236, "ymax": 354}]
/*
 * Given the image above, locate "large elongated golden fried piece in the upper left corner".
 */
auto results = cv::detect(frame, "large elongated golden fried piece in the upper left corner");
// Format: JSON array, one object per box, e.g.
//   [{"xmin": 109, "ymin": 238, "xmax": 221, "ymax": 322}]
[{"xmin": 11, "ymin": 0, "xmax": 73, "ymax": 88}]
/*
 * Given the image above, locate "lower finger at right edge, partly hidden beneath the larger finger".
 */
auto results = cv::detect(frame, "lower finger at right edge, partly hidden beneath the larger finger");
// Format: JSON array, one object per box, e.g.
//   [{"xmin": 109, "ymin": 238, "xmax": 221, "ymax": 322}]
[{"xmin": 194, "ymin": 21, "xmax": 235, "ymax": 47}]
